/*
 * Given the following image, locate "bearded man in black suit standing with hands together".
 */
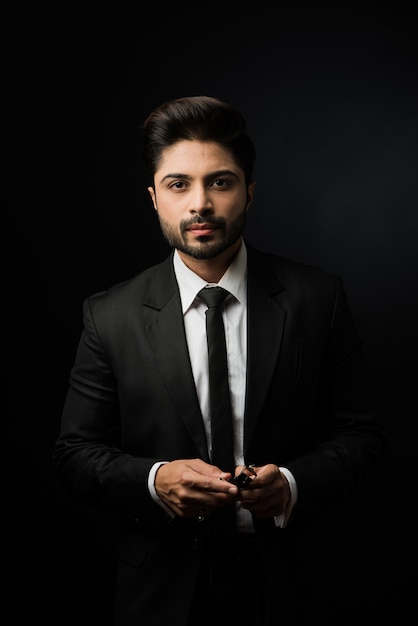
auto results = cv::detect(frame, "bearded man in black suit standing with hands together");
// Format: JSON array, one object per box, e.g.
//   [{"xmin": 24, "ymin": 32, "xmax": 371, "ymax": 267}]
[{"xmin": 54, "ymin": 96, "xmax": 384, "ymax": 626}]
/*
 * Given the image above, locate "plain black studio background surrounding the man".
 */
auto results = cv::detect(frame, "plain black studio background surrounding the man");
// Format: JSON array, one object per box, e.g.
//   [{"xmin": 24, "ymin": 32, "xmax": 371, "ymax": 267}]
[{"xmin": 3, "ymin": 2, "xmax": 418, "ymax": 626}]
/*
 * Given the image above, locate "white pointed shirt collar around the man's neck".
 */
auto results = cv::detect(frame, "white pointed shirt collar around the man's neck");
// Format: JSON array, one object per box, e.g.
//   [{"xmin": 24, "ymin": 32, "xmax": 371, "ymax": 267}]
[{"xmin": 173, "ymin": 241, "xmax": 247, "ymax": 314}]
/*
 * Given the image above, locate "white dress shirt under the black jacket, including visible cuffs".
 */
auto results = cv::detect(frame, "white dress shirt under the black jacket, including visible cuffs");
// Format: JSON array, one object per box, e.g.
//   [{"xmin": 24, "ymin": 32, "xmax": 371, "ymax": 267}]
[{"xmin": 148, "ymin": 242, "xmax": 297, "ymax": 532}]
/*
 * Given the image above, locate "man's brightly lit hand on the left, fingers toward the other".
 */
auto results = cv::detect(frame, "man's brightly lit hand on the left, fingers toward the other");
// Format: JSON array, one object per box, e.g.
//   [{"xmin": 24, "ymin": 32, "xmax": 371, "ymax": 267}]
[{"xmin": 155, "ymin": 459, "xmax": 238, "ymax": 517}]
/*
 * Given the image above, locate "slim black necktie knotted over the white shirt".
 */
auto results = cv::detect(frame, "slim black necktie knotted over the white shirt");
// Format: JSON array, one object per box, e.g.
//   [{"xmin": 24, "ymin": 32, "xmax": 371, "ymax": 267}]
[{"xmin": 198, "ymin": 287, "xmax": 235, "ymax": 475}]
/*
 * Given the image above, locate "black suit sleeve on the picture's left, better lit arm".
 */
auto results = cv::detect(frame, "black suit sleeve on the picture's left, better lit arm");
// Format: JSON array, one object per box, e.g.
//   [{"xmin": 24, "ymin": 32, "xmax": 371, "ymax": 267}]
[{"xmin": 53, "ymin": 300, "xmax": 167, "ymax": 525}]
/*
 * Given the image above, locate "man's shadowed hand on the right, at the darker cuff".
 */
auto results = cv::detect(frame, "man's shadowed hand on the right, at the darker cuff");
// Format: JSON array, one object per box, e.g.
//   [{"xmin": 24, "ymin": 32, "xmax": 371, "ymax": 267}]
[{"xmin": 238, "ymin": 464, "xmax": 290, "ymax": 518}]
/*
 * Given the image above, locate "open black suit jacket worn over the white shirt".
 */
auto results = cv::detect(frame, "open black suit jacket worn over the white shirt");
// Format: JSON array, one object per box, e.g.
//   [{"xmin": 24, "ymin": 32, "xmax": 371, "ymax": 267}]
[{"xmin": 54, "ymin": 244, "xmax": 383, "ymax": 624}]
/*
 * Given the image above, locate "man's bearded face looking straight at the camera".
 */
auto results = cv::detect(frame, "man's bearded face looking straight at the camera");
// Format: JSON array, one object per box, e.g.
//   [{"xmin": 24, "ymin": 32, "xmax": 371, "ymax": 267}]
[{"xmin": 148, "ymin": 140, "xmax": 255, "ymax": 259}]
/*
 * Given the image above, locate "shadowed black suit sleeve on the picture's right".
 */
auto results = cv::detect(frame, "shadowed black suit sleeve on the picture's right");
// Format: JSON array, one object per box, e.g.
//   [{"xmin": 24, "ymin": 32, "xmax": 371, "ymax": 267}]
[{"xmin": 286, "ymin": 278, "xmax": 386, "ymax": 516}]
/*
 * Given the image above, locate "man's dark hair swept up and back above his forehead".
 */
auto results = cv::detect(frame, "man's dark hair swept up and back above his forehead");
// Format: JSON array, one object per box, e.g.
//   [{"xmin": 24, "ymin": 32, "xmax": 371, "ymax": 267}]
[{"xmin": 142, "ymin": 96, "xmax": 255, "ymax": 184}]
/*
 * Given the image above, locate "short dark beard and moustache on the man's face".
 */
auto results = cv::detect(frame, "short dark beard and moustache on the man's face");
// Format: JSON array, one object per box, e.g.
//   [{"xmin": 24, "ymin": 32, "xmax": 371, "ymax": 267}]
[{"xmin": 157, "ymin": 208, "xmax": 247, "ymax": 259}]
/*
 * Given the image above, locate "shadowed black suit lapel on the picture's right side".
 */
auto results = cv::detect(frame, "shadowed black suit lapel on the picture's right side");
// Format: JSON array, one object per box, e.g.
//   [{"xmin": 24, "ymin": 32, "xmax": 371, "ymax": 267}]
[{"xmin": 244, "ymin": 244, "xmax": 286, "ymax": 454}]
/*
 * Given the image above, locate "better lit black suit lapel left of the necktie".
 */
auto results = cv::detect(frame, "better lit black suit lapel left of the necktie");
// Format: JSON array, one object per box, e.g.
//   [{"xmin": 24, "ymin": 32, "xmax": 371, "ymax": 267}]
[{"xmin": 144, "ymin": 257, "xmax": 208, "ymax": 460}]
